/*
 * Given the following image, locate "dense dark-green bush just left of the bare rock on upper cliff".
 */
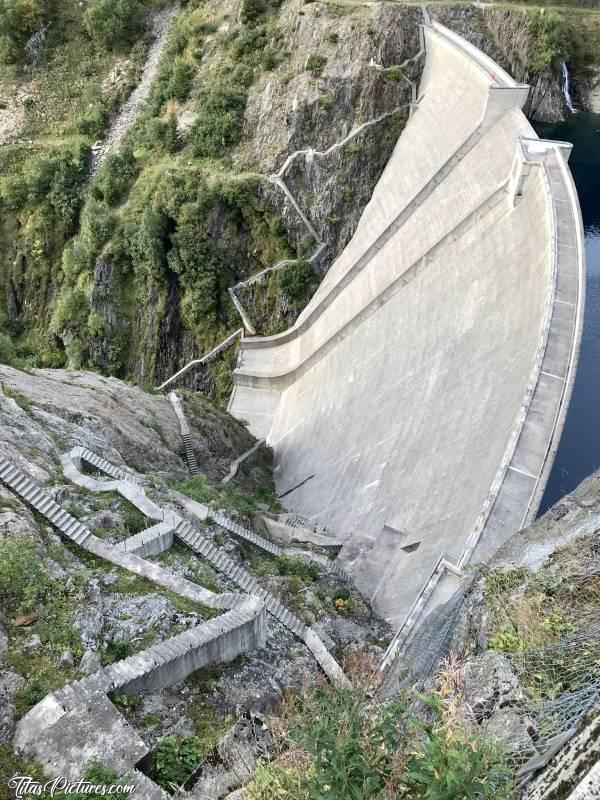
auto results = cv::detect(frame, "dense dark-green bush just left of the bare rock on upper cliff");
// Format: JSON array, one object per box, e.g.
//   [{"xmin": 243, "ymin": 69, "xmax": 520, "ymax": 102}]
[{"xmin": 190, "ymin": 84, "xmax": 246, "ymax": 157}]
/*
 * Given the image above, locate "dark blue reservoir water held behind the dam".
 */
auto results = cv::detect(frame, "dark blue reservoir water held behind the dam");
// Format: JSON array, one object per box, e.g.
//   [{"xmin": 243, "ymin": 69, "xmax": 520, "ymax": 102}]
[{"xmin": 536, "ymin": 114, "xmax": 600, "ymax": 514}]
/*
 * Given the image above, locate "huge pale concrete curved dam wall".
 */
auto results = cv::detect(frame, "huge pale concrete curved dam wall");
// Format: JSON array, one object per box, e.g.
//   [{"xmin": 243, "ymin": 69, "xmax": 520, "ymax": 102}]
[{"xmin": 230, "ymin": 24, "xmax": 584, "ymax": 624}]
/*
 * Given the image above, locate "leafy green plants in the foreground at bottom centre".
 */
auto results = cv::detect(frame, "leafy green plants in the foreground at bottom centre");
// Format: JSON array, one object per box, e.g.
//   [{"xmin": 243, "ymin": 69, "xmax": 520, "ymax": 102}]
[{"xmin": 248, "ymin": 671, "xmax": 511, "ymax": 800}]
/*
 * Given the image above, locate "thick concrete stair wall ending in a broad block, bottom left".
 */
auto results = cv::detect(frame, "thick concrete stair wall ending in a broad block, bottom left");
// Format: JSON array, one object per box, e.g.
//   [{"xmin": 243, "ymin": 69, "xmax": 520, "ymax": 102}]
[{"xmin": 15, "ymin": 597, "xmax": 265, "ymax": 800}]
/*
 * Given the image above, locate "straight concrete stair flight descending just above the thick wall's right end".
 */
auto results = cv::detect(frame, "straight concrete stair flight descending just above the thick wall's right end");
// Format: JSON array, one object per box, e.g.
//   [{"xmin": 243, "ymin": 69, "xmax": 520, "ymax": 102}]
[{"xmin": 175, "ymin": 522, "xmax": 307, "ymax": 639}]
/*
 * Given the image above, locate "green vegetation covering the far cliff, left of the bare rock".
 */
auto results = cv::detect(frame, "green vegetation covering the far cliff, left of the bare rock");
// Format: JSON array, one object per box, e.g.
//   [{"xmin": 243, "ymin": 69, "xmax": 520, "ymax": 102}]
[{"xmin": 0, "ymin": 0, "xmax": 296, "ymax": 384}]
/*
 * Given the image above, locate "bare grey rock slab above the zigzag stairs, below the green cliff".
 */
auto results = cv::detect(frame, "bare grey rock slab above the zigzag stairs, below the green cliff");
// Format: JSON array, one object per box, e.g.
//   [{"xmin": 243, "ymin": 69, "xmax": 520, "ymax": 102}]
[{"xmin": 0, "ymin": 365, "xmax": 264, "ymax": 478}]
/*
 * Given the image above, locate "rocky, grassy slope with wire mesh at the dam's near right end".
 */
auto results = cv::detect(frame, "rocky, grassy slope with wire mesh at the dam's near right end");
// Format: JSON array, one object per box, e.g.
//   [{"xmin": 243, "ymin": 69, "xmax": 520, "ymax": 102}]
[{"xmin": 404, "ymin": 473, "xmax": 600, "ymax": 768}]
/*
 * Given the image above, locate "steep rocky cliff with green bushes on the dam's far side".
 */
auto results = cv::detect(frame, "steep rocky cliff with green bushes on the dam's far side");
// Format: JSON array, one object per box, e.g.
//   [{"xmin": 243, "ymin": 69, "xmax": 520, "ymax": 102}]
[{"xmin": 0, "ymin": 0, "xmax": 598, "ymax": 388}]
